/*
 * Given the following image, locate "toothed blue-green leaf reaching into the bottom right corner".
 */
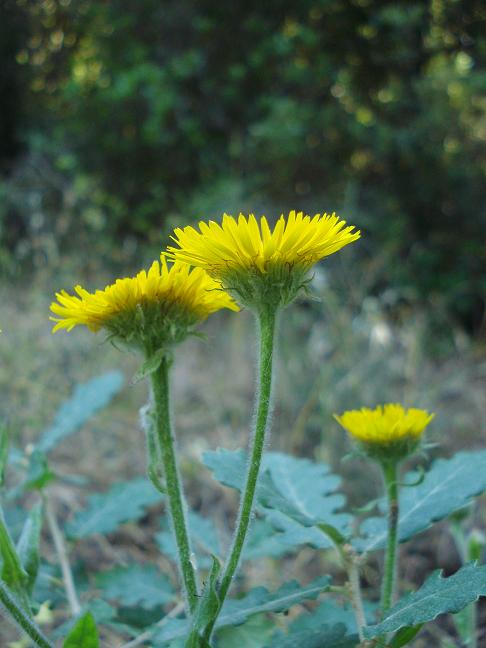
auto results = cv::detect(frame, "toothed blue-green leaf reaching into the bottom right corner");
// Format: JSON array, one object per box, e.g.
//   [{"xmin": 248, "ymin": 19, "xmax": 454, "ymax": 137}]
[{"xmin": 365, "ymin": 563, "xmax": 486, "ymax": 639}]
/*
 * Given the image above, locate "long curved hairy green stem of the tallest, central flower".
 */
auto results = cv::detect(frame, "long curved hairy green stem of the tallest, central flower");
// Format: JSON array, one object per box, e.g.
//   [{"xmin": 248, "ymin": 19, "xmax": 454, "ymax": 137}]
[{"xmin": 204, "ymin": 308, "xmax": 277, "ymax": 641}]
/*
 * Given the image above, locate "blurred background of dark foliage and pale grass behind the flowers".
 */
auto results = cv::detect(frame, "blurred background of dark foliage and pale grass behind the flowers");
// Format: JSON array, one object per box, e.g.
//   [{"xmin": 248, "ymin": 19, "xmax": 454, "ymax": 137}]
[{"xmin": 0, "ymin": 0, "xmax": 486, "ymax": 644}]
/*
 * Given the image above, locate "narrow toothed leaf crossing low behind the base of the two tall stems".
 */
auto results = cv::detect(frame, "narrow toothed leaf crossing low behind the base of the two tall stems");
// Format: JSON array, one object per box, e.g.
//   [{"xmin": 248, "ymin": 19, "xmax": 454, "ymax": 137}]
[{"xmin": 153, "ymin": 576, "xmax": 331, "ymax": 643}]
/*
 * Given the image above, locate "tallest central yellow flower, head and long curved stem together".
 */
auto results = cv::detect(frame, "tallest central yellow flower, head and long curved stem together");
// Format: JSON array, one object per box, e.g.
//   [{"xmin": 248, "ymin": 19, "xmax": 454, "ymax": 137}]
[{"xmin": 168, "ymin": 211, "xmax": 360, "ymax": 641}]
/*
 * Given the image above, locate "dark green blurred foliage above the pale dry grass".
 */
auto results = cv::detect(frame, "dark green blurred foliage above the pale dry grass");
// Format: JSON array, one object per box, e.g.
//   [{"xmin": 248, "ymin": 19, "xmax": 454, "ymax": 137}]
[{"xmin": 0, "ymin": 0, "xmax": 486, "ymax": 327}]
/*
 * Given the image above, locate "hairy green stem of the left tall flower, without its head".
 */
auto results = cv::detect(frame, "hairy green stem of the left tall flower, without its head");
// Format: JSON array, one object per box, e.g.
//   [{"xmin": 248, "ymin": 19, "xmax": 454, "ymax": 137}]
[{"xmin": 151, "ymin": 358, "xmax": 198, "ymax": 612}]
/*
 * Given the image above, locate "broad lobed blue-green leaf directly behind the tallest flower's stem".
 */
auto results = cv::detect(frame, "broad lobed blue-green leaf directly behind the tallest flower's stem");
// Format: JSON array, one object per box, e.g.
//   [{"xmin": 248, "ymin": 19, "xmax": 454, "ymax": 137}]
[{"xmin": 203, "ymin": 449, "xmax": 351, "ymax": 549}]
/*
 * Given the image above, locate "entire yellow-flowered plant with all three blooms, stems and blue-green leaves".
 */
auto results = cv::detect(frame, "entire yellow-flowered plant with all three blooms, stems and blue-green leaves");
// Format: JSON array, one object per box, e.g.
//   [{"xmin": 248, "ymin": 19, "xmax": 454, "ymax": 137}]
[{"xmin": 0, "ymin": 212, "xmax": 486, "ymax": 648}]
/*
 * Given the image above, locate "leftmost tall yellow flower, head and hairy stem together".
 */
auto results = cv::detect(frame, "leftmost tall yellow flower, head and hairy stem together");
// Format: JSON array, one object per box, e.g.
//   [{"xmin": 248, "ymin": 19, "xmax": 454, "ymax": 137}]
[{"xmin": 51, "ymin": 256, "xmax": 238, "ymax": 612}]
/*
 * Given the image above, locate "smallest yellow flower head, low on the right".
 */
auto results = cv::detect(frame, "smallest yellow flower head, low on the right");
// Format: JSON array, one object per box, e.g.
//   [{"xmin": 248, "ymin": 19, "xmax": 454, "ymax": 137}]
[{"xmin": 334, "ymin": 403, "xmax": 435, "ymax": 460}]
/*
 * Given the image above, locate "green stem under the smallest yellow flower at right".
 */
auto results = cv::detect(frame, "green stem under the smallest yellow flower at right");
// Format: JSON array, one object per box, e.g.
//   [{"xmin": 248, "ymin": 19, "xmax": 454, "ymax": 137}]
[{"xmin": 381, "ymin": 462, "xmax": 399, "ymax": 618}]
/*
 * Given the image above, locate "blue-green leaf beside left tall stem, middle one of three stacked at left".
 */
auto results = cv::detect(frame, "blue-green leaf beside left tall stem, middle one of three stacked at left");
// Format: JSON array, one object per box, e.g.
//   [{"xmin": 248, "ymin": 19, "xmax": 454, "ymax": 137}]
[{"xmin": 66, "ymin": 477, "xmax": 162, "ymax": 538}]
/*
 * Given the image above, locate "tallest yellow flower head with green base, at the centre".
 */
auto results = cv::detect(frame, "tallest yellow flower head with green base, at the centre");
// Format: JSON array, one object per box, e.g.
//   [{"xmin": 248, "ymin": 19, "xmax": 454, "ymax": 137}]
[{"xmin": 168, "ymin": 211, "xmax": 360, "ymax": 307}]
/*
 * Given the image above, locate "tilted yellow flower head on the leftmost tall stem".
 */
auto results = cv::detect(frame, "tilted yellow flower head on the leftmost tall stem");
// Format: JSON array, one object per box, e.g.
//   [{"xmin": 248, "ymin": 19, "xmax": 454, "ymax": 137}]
[{"xmin": 50, "ymin": 256, "xmax": 238, "ymax": 351}]
